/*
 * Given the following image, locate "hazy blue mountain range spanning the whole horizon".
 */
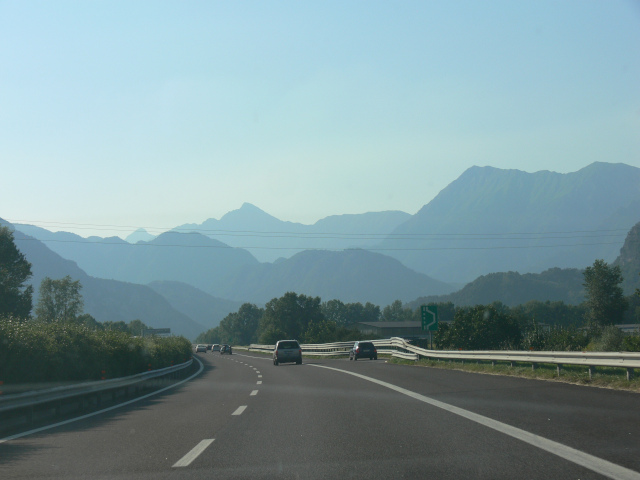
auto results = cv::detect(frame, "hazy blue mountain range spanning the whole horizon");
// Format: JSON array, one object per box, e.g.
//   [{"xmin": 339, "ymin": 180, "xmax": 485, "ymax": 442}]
[{"xmin": 6, "ymin": 163, "xmax": 640, "ymax": 338}]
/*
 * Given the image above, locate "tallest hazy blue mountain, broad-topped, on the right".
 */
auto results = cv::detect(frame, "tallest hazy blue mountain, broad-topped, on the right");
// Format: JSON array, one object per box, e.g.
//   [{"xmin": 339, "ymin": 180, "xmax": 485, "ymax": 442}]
[{"xmin": 379, "ymin": 163, "xmax": 640, "ymax": 283}]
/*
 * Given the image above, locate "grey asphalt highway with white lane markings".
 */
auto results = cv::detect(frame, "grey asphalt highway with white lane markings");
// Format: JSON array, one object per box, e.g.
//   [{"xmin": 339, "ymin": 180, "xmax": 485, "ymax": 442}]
[{"xmin": 0, "ymin": 352, "xmax": 640, "ymax": 480}]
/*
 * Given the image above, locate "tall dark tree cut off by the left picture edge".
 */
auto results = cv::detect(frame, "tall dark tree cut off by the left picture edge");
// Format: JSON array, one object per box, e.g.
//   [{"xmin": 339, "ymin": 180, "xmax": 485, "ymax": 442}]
[{"xmin": 0, "ymin": 227, "xmax": 33, "ymax": 318}]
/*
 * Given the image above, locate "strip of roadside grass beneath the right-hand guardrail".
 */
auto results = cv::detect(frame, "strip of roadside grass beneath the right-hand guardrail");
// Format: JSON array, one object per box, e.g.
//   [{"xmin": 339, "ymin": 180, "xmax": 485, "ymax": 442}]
[{"xmin": 388, "ymin": 357, "xmax": 640, "ymax": 393}]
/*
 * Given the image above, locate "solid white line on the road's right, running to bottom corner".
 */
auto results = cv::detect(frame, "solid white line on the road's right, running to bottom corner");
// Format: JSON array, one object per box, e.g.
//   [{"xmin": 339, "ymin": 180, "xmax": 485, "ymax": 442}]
[{"xmin": 309, "ymin": 364, "xmax": 640, "ymax": 480}]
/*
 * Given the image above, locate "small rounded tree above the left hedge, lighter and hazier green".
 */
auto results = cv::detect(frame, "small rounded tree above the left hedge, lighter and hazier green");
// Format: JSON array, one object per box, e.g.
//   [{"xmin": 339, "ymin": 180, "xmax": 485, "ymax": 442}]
[{"xmin": 36, "ymin": 275, "xmax": 83, "ymax": 322}]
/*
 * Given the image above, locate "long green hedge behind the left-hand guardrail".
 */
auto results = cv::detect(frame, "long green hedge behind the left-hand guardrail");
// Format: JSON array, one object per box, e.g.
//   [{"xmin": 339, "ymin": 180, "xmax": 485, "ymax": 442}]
[{"xmin": 0, "ymin": 319, "xmax": 191, "ymax": 385}]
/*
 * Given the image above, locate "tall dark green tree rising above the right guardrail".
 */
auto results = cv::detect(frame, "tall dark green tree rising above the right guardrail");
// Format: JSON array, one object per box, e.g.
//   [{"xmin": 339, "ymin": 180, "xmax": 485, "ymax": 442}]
[{"xmin": 583, "ymin": 260, "xmax": 628, "ymax": 327}]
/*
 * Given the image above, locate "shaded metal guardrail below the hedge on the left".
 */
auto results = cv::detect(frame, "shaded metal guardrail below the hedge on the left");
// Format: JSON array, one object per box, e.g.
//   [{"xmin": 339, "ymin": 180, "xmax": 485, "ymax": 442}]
[{"xmin": 0, "ymin": 359, "xmax": 193, "ymax": 431}]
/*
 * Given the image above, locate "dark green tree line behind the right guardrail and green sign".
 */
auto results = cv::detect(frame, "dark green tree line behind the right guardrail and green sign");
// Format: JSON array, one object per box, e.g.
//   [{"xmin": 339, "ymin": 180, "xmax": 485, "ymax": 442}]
[{"xmin": 196, "ymin": 260, "xmax": 640, "ymax": 351}]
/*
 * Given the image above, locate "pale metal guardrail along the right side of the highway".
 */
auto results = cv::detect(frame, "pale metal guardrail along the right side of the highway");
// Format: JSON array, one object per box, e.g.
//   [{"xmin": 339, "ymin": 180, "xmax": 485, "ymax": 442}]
[{"xmin": 249, "ymin": 337, "xmax": 640, "ymax": 380}]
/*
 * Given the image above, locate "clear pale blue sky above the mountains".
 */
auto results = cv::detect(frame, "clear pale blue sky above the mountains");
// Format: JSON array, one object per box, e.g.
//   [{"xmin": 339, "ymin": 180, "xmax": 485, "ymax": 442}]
[{"xmin": 0, "ymin": 0, "xmax": 640, "ymax": 236}]
